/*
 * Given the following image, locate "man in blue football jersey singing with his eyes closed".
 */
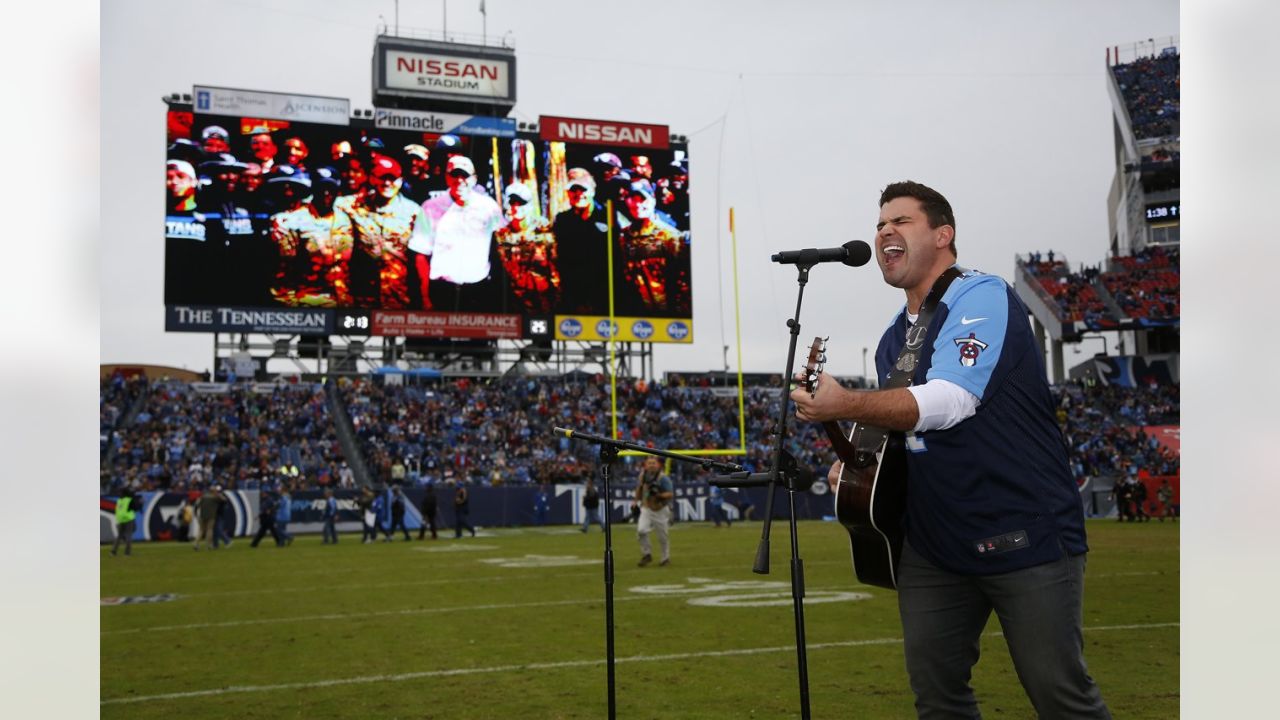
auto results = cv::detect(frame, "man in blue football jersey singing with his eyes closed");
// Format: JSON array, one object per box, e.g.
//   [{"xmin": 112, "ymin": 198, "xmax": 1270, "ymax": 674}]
[{"xmin": 791, "ymin": 182, "xmax": 1111, "ymax": 719}]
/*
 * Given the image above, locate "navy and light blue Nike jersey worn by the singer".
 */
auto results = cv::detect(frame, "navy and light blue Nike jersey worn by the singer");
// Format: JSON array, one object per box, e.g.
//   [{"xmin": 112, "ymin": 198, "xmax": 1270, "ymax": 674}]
[{"xmin": 876, "ymin": 272, "xmax": 1088, "ymax": 575}]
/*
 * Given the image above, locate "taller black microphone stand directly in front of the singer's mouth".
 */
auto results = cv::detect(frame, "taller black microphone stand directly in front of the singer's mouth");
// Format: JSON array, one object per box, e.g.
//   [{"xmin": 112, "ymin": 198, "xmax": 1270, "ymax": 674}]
[{"xmin": 712, "ymin": 257, "xmax": 822, "ymax": 720}]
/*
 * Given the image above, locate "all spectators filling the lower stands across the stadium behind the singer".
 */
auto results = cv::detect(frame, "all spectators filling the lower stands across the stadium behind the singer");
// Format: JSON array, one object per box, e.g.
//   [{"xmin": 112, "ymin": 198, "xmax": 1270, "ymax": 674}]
[{"xmin": 100, "ymin": 363, "xmax": 1178, "ymax": 493}]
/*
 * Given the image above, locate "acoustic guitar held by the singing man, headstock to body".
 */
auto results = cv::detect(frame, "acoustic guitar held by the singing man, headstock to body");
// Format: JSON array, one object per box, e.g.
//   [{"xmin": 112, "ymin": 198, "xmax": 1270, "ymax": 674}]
[{"xmin": 801, "ymin": 337, "xmax": 906, "ymax": 589}]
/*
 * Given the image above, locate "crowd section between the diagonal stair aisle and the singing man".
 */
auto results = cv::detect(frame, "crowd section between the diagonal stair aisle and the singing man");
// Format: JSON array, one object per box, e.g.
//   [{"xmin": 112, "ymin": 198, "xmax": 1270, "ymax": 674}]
[{"xmin": 339, "ymin": 374, "xmax": 831, "ymax": 486}]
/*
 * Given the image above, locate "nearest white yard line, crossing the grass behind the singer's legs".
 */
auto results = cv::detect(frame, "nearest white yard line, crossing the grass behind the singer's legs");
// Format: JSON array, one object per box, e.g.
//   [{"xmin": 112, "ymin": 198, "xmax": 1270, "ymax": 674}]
[{"xmin": 100, "ymin": 620, "xmax": 1179, "ymax": 705}]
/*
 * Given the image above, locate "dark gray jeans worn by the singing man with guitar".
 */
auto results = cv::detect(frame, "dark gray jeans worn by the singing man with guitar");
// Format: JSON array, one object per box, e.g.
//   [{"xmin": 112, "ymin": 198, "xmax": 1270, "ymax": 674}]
[{"xmin": 897, "ymin": 543, "xmax": 1111, "ymax": 720}]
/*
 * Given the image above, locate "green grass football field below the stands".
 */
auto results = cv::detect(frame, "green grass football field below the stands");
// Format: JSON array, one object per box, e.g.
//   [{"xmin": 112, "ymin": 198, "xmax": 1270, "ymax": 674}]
[{"xmin": 101, "ymin": 520, "xmax": 1179, "ymax": 720}]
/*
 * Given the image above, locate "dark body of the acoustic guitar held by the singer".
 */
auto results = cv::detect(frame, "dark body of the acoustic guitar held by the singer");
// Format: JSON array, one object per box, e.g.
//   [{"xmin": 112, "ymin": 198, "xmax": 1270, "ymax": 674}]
[{"xmin": 836, "ymin": 427, "xmax": 906, "ymax": 589}]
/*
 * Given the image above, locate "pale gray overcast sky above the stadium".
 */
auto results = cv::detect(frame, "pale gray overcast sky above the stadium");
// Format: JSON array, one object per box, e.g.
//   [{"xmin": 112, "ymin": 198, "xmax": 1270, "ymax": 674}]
[{"xmin": 101, "ymin": 0, "xmax": 1179, "ymax": 374}]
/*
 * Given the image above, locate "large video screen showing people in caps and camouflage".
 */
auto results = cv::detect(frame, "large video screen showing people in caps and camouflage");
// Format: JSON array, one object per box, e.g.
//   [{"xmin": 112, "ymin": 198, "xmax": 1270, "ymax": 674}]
[{"xmin": 165, "ymin": 110, "xmax": 692, "ymax": 319}]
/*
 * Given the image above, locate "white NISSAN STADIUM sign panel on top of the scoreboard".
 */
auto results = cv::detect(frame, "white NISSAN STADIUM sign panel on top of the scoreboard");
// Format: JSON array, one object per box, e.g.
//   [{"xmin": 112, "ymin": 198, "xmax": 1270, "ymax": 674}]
[{"xmin": 379, "ymin": 47, "xmax": 516, "ymax": 100}]
